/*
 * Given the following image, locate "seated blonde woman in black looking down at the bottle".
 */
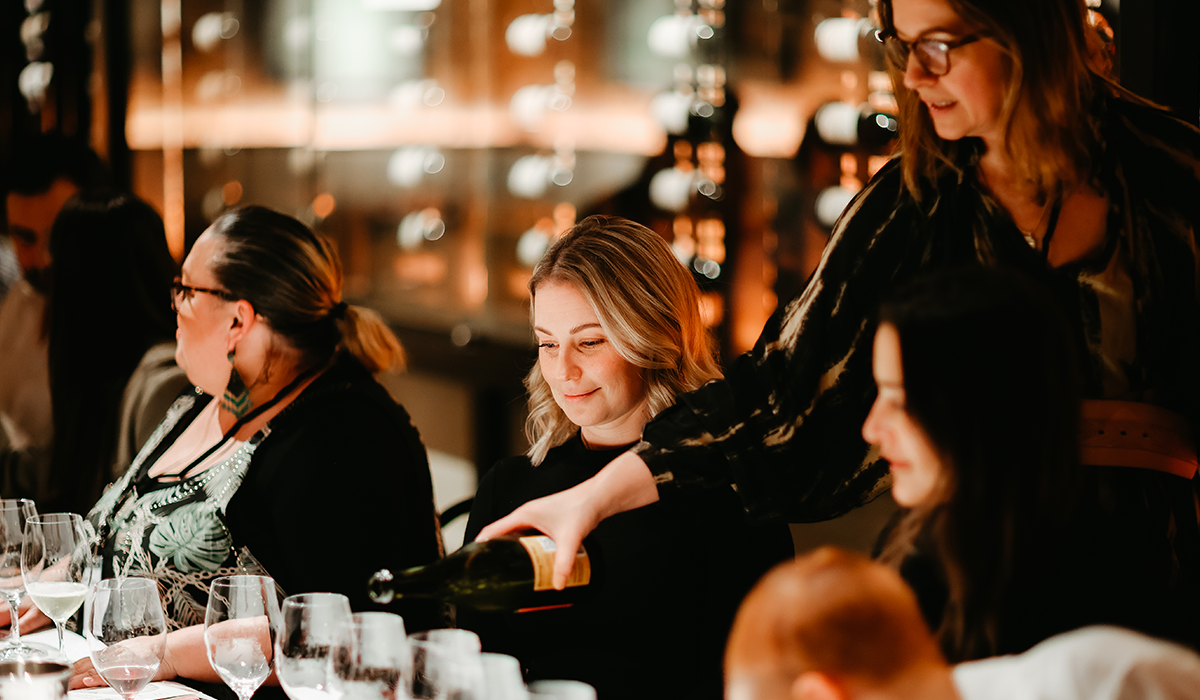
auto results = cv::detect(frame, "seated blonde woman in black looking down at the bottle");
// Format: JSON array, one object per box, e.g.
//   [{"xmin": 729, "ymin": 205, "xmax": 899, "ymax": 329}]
[{"xmin": 458, "ymin": 216, "xmax": 794, "ymax": 699}]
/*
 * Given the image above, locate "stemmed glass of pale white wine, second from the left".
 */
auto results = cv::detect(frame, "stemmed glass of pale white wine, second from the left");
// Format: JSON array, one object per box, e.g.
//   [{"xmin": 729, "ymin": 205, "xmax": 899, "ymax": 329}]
[{"xmin": 20, "ymin": 513, "xmax": 91, "ymax": 656}]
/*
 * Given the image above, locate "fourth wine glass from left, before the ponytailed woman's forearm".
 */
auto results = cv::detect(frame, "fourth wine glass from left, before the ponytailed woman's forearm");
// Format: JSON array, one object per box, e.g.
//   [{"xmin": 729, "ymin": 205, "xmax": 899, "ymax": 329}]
[{"xmin": 204, "ymin": 575, "xmax": 280, "ymax": 700}]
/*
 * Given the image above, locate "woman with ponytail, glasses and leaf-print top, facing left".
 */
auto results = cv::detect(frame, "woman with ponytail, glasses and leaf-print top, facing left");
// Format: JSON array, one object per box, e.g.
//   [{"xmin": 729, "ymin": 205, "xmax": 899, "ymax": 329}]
[{"xmin": 82, "ymin": 207, "xmax": 440, "ymax": 629}]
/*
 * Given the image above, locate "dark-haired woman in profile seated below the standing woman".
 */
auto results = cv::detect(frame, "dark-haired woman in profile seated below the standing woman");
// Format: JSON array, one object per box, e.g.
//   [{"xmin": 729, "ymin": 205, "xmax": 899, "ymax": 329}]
[{"xmin": 863, "ymin": 269, "xmax": 1200, "ymax": 659}]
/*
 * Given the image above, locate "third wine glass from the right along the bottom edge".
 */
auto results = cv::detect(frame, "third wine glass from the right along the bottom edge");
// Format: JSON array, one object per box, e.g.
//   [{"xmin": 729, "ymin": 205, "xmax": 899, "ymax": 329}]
[{"xmin": 408, "ymin": 629, "xmax": 484, "ymax": 700}]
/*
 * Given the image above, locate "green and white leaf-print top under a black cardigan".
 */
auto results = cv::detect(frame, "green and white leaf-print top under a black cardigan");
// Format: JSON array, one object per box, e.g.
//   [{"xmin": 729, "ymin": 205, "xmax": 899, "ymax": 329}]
[{"xmin": 88, "ymin": 389, "xmax": 271, "ymax": 629}]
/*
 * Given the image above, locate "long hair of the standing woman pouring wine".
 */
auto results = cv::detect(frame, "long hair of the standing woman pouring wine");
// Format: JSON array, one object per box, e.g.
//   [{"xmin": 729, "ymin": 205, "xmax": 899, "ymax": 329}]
[{"xmin": 878, "ymin": 0, "xmax": 1118, "ymax": 199}]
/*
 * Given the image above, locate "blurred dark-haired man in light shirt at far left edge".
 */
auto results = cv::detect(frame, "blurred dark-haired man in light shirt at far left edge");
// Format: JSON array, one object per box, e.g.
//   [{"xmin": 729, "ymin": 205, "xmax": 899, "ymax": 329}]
[{"xmin": 0, "ymin": 134, "xmax": 107, "ymax": 510}]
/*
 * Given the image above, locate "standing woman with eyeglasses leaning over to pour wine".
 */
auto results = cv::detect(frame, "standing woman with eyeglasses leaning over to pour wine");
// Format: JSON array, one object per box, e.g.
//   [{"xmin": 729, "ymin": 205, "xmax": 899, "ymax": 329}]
[{"xmin": 481, "ymin": 0, "xmax": 1200, "ymax": 657}]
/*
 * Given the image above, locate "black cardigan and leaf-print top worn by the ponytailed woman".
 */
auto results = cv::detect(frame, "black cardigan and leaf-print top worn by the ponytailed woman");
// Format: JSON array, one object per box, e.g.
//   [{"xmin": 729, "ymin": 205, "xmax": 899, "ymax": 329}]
[{"xmin": 89, "ymin": 355, "xmax": 442, "ymax": 630}]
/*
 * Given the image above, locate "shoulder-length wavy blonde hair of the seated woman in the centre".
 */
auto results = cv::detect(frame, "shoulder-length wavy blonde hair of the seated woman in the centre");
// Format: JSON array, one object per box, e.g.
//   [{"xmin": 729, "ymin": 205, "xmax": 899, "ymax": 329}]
[{"xmin": 526, "ymin": 216, "xmax": 721, "ymax": 465}]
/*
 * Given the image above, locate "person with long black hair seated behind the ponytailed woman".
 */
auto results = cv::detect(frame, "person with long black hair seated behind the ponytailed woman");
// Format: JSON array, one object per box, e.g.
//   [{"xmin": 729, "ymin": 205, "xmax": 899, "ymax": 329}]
[{"xmin": 45, "ymin": 191, "xmax": 185, "ymax": 513}]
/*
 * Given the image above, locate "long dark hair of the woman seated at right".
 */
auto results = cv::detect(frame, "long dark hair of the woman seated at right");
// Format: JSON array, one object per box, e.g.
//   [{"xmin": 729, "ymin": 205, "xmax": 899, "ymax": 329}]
[{"xmin": 880, "ymin": 267, "xmax": 1080, "ymax": 660}]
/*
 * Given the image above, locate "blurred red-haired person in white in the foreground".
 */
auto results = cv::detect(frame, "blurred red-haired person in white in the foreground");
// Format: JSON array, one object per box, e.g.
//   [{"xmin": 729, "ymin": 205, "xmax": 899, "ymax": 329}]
[{"xmin": 725, "ymin": 548, "xmax": 1200, "ymax": 700}]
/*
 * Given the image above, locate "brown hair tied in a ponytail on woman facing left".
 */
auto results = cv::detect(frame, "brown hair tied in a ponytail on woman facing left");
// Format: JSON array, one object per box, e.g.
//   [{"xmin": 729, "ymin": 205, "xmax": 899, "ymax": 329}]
[{"xmin": 209, "ymin": 207, "xmax": 404, "ymax": 373}]
